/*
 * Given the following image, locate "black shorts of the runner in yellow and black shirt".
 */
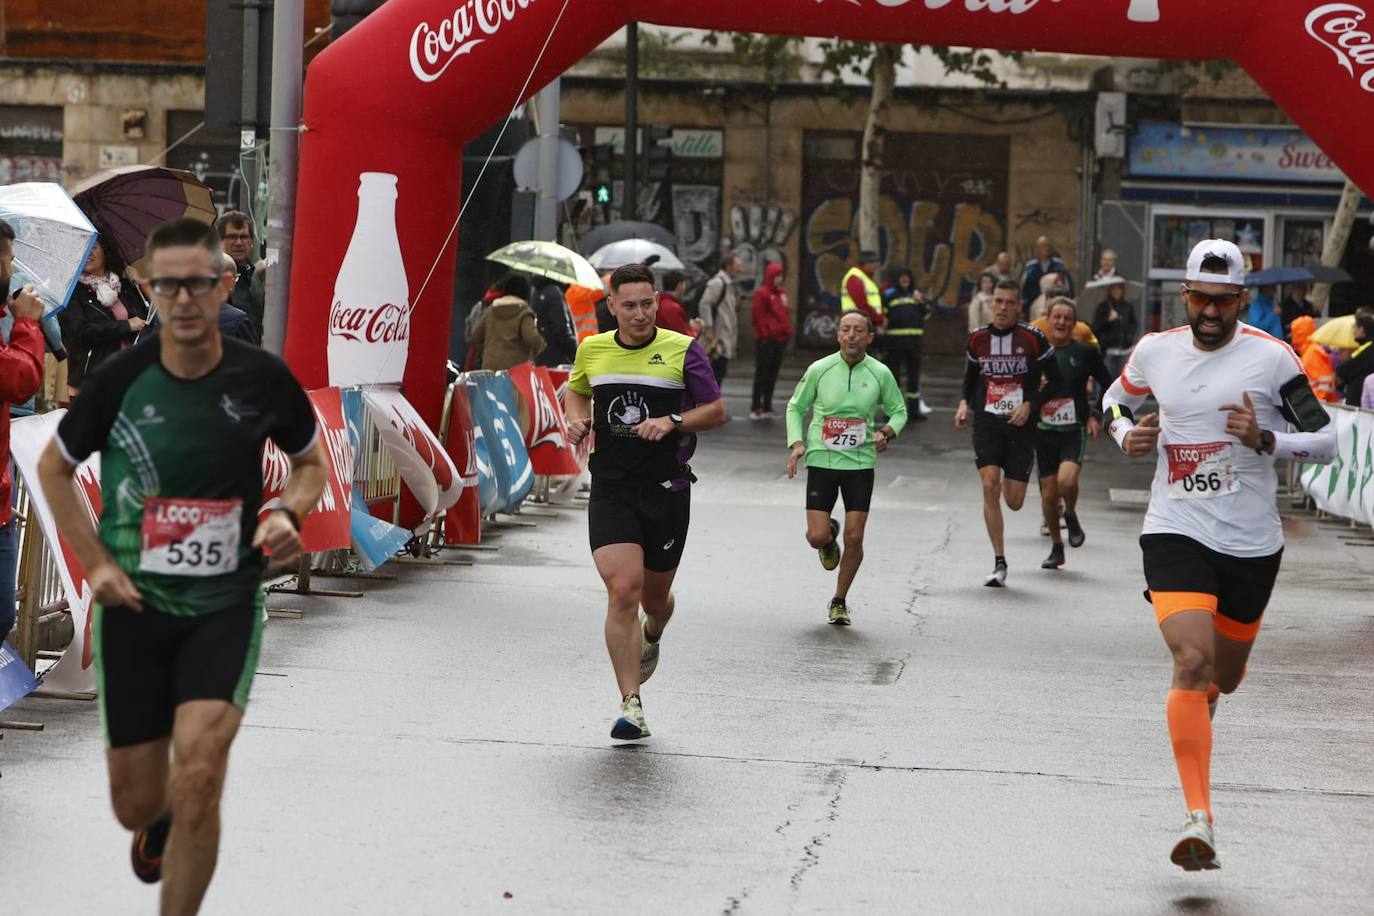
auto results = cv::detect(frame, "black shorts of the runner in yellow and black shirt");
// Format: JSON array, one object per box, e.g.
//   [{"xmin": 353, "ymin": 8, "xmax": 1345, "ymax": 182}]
[{"xmin": 587, "ymin": 481, "xmax": 691, "ymax": 573}]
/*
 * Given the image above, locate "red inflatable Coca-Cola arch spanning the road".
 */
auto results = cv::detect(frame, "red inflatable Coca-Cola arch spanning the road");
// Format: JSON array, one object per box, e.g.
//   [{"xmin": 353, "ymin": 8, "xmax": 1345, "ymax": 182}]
[{"xmin": 286, "ymin": 0, "xmax": 1374, "ymax": 426}]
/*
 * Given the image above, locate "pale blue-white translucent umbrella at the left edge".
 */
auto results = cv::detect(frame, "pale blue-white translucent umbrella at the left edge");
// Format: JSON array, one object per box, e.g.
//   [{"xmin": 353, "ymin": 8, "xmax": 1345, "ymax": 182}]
[{"xmin": 0, "ymin": 181, "xmax": 96, "ymax": 321}]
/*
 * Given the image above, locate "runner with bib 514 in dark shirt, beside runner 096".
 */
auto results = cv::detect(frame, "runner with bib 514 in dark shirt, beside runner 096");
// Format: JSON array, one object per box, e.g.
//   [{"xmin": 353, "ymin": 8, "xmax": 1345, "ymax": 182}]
[{"xmin": 1033, "ymin": 298, "xmax": 1112, "ymax": 570}]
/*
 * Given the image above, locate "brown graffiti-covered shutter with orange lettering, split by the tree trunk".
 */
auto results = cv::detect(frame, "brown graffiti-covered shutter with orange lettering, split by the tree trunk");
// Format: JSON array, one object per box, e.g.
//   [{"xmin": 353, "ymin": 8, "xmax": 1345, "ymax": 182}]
[{"xmin": 798, "ymin": 132, "xmax": 1010, "ymax": 347}]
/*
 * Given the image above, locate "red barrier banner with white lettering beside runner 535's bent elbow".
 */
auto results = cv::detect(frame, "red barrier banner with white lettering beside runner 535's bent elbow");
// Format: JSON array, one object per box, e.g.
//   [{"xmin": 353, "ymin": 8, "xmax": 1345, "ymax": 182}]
[{"xmin": 258, "ymin": 389, "xmax": 353, "ymax": 553}]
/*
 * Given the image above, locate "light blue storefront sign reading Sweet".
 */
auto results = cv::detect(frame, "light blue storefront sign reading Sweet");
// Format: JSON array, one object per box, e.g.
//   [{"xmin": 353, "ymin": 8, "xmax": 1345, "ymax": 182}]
[{"xmin": 1131, "ymin": 121, "xmax": 1345, "ymax": 184}]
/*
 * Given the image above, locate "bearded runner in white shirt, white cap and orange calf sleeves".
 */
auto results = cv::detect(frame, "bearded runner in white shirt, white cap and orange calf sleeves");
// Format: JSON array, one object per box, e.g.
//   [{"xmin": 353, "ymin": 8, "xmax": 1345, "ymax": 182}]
[{"xmin": 1103, "ymin": 239, "xmax": 1336, "ymax": 871}]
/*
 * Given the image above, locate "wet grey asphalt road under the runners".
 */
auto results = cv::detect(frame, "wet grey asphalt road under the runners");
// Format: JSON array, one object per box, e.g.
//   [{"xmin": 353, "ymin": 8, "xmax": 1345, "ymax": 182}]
[{"xmin": 0, "ymin": 374, "xmax": 1374, "ymax": 916}]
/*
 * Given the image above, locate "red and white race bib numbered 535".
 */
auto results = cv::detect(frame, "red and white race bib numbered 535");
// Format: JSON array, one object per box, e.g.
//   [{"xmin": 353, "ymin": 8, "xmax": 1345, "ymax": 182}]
[{"xmin": 139, "ymin": 497, "xmax": 243, "ymax": 577}]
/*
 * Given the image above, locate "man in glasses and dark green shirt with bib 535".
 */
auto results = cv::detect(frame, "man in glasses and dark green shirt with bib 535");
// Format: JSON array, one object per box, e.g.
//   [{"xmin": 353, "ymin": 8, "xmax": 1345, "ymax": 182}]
[{"xmin": 38, "ymin": 220, "xmax": 327, "ymax": 913}]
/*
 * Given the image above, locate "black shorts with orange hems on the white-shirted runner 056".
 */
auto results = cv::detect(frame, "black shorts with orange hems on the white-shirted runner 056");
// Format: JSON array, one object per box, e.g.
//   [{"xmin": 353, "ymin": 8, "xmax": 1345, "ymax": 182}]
[{"xmin": 1140, "ymin": 534, "xmax": 1283, "ymax": 639}]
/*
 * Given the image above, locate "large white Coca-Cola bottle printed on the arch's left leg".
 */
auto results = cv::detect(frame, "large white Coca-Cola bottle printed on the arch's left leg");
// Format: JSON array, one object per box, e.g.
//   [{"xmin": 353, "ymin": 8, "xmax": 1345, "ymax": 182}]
[{"xmin": 327, "ymin": 172, "xmax": 411, "ymax": 387}]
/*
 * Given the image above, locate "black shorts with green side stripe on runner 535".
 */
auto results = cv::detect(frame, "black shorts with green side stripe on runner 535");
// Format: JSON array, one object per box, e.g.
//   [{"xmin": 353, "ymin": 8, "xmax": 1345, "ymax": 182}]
[{"xmin": 92, "ymin": 589, "xmax": 262, "ymax": 748}]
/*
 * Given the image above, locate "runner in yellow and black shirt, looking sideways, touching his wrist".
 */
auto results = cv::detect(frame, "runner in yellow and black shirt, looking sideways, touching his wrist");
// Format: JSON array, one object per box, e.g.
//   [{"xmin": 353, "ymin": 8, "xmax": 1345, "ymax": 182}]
[{"xmin": 566, "ymin": 264, "xmax": 725, "ymax": 740}]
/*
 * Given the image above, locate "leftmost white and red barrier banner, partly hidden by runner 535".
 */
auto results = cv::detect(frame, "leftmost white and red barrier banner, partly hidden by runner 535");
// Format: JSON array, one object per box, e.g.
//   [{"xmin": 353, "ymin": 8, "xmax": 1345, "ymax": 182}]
[{"xmin": 10, "ymin": 411, "xmax": 102, "ymax": 694}]
